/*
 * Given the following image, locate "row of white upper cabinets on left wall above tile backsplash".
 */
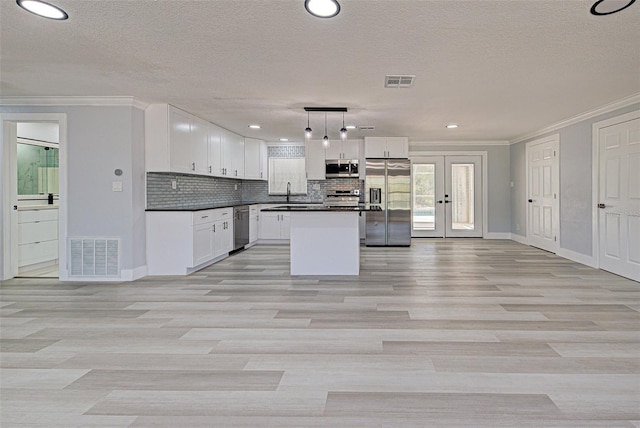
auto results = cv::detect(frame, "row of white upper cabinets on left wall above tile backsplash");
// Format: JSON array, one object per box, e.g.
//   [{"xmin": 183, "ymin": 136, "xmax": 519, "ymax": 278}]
[{"xmin": 145, "ymin": 104, "xmax": 245, "ymax": 178}]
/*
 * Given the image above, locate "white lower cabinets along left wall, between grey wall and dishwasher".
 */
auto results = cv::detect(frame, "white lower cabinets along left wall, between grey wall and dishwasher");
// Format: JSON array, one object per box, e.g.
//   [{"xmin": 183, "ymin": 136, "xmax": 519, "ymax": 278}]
[{"xmin": 146, "ymin": 208, "xmax": 233, "ymax": 275}]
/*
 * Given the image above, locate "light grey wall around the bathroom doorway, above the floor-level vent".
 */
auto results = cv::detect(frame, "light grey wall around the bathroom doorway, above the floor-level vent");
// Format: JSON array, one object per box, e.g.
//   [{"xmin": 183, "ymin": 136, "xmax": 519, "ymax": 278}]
[{"xmin": 0, "ymin": 105, "xmax": 146, "ymax": 279}]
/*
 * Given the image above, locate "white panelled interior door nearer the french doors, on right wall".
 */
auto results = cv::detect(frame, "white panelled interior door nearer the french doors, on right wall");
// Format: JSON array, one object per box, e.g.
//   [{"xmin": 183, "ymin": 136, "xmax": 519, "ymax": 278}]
[{"xmin": 525, "ymin": 135, "xmax": 559, "ymax": 253}]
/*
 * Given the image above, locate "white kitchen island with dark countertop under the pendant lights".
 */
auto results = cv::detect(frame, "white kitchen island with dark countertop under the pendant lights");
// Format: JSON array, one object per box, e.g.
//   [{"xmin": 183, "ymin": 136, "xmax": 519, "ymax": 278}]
[{"xmin": 264, "ymin": 206, "xmax": 376, "ymax": 275}]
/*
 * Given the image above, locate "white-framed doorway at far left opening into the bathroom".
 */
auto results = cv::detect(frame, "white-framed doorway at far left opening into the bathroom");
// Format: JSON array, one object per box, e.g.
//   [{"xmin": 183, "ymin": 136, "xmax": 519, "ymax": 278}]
[{"xmin": 0, "ymin": 113, "xmax": 66, "ymax": 279}]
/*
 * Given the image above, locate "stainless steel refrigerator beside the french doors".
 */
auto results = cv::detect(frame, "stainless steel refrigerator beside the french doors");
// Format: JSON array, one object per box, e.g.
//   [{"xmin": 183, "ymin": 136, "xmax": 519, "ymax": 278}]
[{"xmin": 365, "ymin": 159, "xmax": 411, "ymax": 247}]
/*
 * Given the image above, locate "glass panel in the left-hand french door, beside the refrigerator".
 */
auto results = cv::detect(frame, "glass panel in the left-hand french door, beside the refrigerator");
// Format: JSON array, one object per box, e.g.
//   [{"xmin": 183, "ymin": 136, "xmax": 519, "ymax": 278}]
[{"xmin": 412, "ymin": 163, "xmax": 436, "ymax": 230}]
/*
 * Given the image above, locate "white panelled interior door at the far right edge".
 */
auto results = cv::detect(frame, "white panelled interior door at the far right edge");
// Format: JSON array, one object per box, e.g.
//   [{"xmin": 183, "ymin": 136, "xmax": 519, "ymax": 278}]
[{"xmin": 598, "ymin": 119, "xmax": 640, "ymax": 281}]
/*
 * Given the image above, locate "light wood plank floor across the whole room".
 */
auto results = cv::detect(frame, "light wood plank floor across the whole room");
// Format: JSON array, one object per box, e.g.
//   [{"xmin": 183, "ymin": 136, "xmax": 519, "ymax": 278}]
[{"xmin": 0, "ymin": 239, "xmax": 640, "ymax": 428}]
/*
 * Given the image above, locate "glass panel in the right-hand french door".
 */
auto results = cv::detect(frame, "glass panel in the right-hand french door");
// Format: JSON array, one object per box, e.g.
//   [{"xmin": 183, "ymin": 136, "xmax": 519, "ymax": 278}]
[{"xmin": 451, "ymin": 163, "xmax": 474, "ymax": 230}]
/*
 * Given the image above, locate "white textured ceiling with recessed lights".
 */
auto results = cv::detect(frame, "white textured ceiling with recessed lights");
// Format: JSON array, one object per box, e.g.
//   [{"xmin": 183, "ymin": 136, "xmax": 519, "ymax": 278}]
[{"xmin": 0, "ymin": 0, "xmax": 640, "ymax": 141}]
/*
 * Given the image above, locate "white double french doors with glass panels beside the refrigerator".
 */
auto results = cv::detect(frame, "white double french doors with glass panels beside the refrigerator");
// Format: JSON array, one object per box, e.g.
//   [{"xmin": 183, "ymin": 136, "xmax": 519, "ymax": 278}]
[{"xmin": 411, "ymin": 155, "xmax": 482, "ymax": 238}]
